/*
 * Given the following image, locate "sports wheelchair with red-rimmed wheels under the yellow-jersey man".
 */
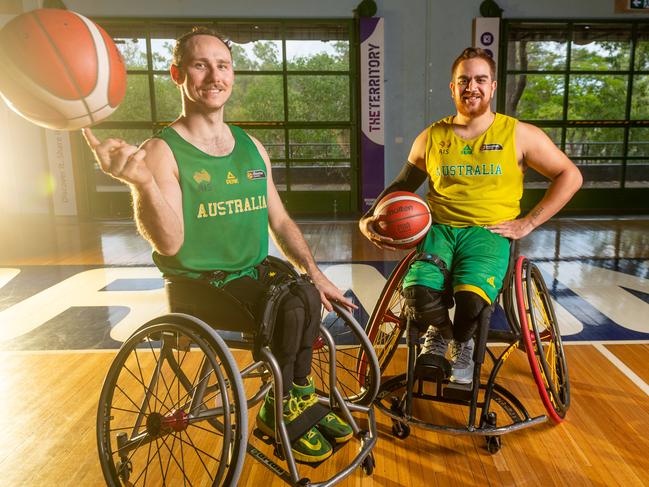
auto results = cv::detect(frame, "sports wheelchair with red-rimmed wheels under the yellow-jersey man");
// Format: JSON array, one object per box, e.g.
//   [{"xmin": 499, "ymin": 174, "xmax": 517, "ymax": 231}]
[{"xmin": 358, "ymin": 242, "xmax": 570, "ymax": 453}]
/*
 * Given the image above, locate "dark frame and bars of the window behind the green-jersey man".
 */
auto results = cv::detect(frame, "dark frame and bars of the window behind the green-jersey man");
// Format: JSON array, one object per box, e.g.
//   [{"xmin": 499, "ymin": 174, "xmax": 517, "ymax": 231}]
[{"xmin": 74, "ymin": 17, "xmax": 360, "ymax": 218}]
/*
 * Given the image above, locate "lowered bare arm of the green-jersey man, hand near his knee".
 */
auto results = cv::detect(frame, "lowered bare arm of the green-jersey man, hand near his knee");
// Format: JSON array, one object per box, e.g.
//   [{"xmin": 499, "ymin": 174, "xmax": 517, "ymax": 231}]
[{"xmin": 251, "ymin": 137, "xmax": 356, "ymax": 311}]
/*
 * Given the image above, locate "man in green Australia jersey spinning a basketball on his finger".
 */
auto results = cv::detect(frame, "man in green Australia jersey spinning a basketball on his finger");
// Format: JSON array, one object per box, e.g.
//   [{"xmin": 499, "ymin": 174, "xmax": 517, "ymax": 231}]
[{"xmin": 84, "ymin": 28, "xmax": 354, "ymax": 462}]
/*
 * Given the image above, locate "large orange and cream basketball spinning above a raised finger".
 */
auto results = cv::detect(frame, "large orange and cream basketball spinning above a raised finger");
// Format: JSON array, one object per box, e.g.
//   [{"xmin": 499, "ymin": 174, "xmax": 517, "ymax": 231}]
[{"xmin": 0, "ymin": 9, "xmax": 126, "ymax": 130}]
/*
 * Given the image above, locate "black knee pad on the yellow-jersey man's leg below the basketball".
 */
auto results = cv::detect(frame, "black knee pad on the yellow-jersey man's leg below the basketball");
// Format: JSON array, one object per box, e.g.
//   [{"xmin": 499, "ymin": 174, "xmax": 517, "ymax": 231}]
[{"xmin": 403, "ymin": 286, "xmax": 451, "ymax": 333}]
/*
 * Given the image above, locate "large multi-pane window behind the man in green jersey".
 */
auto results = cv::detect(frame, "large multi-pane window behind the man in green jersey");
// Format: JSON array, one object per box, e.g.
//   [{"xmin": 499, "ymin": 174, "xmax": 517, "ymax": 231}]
[{"xmin": 79, "ymin": 19, "xmax": 357, "ymax": 216}]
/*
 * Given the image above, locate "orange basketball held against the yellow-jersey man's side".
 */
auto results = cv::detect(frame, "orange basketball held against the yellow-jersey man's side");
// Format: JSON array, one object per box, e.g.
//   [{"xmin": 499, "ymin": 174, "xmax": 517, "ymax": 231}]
[{"xmin": 374, "ymin": 191, "xmax": 432, "ymax": 249}]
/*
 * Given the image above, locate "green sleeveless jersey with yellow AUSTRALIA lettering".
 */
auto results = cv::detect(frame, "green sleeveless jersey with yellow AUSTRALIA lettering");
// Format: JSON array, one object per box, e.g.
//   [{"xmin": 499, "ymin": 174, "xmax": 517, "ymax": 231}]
[{"xmin": 153, "ymin": 125, "xmax": 268, "ymax": 284}]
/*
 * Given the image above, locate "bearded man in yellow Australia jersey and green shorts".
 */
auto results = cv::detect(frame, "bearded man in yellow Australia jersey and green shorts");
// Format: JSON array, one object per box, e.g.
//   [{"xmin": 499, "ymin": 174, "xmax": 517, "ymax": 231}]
[{"xmin": 359, "ymin": 48, "xmax": 582, "ymax": 384}]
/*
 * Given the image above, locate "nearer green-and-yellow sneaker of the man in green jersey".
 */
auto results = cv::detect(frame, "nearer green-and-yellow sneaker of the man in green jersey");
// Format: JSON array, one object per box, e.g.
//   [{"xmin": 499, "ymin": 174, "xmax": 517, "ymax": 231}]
[{"xmin": 257, "ymin": 393, "xmax": 333, "ymax": 463}]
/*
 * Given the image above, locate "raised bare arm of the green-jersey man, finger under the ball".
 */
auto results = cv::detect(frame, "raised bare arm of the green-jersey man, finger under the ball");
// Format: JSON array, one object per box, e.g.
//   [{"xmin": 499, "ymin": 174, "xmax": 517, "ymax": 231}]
[{"xmin": 83, "ymin": 129, "xmax": 184, "ymax": 255}]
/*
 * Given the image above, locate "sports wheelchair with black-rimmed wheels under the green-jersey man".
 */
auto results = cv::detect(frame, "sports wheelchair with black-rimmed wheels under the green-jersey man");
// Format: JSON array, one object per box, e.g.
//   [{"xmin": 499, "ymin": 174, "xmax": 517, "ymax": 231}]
[{"xmin": 97, "ymin": 257, "xmax": 380, "ymax": 486}]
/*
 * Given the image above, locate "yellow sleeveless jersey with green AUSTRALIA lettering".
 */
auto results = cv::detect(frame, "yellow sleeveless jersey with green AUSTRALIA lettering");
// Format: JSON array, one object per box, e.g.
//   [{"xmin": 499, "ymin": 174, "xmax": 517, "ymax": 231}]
[{"xmin": 426, "ymin": 113, "xmax": 523, "ymax": 227}]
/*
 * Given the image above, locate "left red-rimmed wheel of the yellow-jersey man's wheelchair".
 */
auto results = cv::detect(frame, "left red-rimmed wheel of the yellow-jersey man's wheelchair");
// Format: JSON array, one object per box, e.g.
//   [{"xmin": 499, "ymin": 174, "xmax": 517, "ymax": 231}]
[{"xmin": 359, "ymin": 251, "xmax": 415, "ymax": 373}]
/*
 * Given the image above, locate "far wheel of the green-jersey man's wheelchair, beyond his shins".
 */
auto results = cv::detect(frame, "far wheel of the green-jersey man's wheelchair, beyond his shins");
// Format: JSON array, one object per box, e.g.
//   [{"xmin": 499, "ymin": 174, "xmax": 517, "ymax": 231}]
[{"xmin": 311, "ymin": 303, "xmax": 381, "ymax": 406}]
